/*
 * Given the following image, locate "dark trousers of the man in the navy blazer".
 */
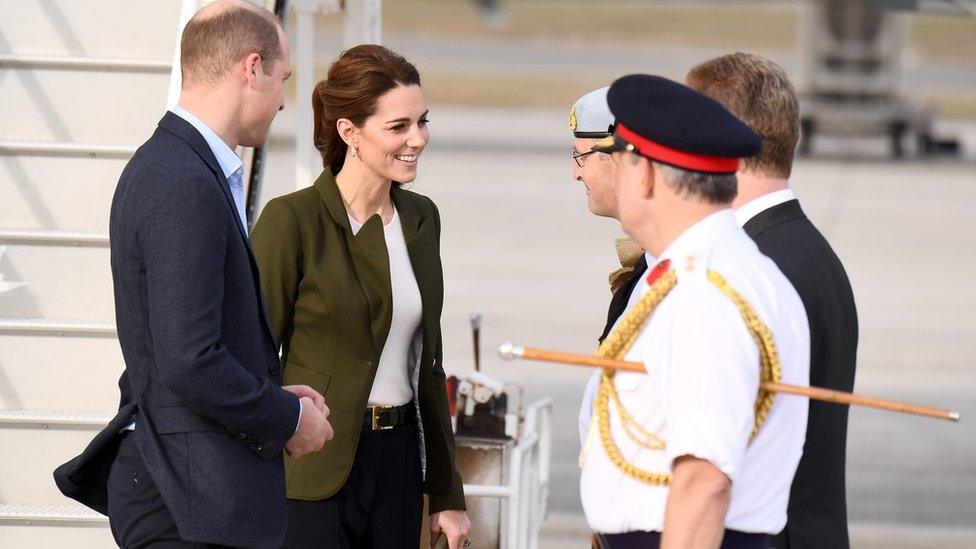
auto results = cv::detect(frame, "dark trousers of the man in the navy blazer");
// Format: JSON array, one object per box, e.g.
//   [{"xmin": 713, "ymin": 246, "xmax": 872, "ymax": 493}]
[{"xmin": 107, "ymin": 432, "xmax": 234, "ymax": 549}]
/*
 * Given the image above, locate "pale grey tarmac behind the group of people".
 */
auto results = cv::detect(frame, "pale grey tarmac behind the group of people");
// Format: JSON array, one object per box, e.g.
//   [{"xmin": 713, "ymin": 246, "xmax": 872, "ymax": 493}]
[{"xmin": 264, "ymin": 105, "xmax": 976, "ymax": 548}]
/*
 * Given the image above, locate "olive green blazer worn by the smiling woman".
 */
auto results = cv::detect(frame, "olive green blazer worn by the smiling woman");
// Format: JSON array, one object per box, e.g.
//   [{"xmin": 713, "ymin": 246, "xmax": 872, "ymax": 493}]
[{"xmin": 251, "ymin": 169, "xmax": 464, "ymax": 513}]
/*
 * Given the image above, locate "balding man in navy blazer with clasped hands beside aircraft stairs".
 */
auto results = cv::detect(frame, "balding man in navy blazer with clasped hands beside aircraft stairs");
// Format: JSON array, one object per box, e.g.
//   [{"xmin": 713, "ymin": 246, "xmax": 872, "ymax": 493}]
[{"xmin": 55, "ymin": 0, "xmax": 332, "ymax": 548}]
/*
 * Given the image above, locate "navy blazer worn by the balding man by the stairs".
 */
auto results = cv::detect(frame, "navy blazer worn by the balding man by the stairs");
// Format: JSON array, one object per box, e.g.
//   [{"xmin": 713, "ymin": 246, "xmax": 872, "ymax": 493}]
[{"xmin": 55, "ymin": 113, "xmax": 299, "ymax": 548}]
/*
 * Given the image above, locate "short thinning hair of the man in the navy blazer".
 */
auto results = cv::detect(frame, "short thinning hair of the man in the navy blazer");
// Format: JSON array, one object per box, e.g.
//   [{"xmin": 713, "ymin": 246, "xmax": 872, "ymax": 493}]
[{"xmin": 180, "ymin": 2, "xmax": 281, "ymax": 85}]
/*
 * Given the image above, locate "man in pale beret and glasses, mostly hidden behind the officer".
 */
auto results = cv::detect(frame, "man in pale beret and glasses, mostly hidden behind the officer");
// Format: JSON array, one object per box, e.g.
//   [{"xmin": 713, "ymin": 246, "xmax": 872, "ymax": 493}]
[{"xmin": 569, "ymin": 86, "xmax": 647, "ymax": 450}]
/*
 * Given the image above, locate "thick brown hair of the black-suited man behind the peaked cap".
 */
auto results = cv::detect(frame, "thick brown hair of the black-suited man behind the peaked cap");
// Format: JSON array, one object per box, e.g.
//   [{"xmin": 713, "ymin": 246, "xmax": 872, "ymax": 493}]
[{"xmin": 685, "ymin": 52, "xmax": 800, "ymax": 179}]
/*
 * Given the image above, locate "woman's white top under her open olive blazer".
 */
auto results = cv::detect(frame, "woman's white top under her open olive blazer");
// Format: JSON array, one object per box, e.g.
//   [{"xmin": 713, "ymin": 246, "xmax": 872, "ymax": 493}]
[{"xmin": 349, "ymin": 209, "xmax": 423, "ymax": 406}]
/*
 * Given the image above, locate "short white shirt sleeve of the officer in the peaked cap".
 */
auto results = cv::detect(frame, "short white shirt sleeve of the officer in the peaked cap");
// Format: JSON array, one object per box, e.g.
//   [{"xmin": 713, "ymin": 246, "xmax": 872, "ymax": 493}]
[{"xmin": 665, "ymin": 281, "xmax": 759, "ymax": 481}]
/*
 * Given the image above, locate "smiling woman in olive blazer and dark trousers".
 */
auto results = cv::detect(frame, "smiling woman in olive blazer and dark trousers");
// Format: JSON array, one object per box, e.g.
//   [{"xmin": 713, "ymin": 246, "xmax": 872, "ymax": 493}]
[{"xmin": 251, "ymin": 45, "xmax": 470, "ymax": 549}]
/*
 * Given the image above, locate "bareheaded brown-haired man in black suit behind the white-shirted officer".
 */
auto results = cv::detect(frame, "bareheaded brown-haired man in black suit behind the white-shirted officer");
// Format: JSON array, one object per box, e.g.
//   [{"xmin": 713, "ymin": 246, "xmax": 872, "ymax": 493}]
[{"xmin": 685, "ymin": 53, "xmax": 857, "ymax": 549}]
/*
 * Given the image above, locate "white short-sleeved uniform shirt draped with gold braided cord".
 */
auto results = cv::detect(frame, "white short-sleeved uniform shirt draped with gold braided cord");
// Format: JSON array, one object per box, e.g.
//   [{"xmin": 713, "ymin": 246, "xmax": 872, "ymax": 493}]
[{"xmin": 580, "ymin": 209, "xmax": 810, "ymax": 534}]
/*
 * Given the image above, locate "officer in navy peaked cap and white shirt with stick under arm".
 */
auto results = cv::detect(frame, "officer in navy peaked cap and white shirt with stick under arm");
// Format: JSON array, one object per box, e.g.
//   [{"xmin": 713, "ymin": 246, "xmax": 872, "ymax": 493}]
[{"xmin": 580, "ymin": 75, "xmax": 810, "ymax": 549}]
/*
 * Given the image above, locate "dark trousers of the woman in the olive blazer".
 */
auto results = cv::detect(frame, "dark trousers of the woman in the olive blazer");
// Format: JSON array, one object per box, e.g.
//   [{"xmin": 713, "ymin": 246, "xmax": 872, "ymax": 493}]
[{"xmin": 282, "ymin": 415, "xmax": 423, "ymax": 549}]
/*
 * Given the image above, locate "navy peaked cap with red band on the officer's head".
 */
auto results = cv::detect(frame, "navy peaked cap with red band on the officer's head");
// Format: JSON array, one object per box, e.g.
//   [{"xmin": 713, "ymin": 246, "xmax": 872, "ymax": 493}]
[{"xmin": 593, "ymin": 74, "xmax": 762, "ymax": 174}]
